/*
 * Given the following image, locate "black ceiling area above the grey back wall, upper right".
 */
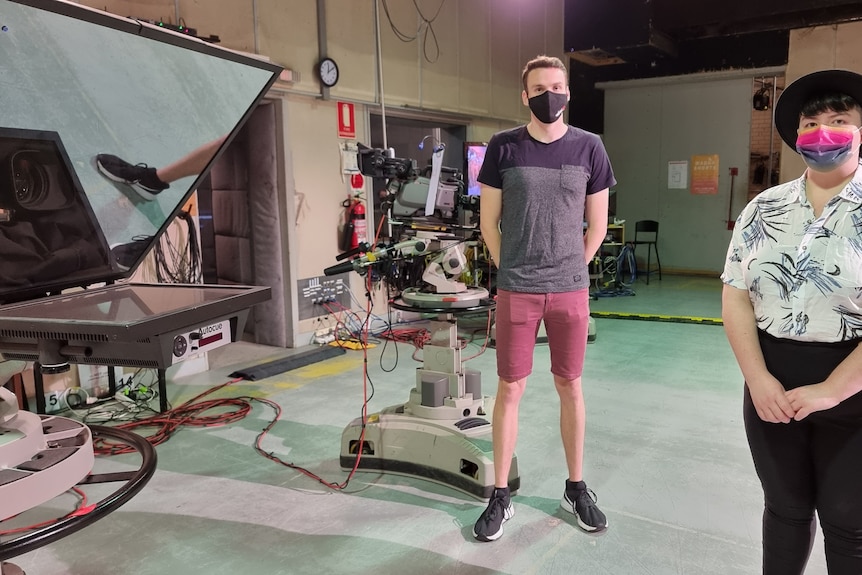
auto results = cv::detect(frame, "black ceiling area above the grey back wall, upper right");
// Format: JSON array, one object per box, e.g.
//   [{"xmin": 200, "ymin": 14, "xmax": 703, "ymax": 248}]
[{"xmin": 564, "ymin": 0, "xmax": 862, "ymax": 132}]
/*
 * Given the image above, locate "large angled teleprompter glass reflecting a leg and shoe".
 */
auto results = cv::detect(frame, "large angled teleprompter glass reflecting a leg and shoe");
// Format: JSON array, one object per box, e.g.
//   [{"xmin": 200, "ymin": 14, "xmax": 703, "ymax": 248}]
[{"xmin": 0, "ymin": 0, "xmax": 281, "ymax": 303}]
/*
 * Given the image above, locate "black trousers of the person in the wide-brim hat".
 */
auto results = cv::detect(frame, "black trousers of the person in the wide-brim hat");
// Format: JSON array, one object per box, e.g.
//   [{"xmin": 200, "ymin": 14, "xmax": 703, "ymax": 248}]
[{"xmin": 743, "ymin": 333, "xmax": 862, "ymax": 575}]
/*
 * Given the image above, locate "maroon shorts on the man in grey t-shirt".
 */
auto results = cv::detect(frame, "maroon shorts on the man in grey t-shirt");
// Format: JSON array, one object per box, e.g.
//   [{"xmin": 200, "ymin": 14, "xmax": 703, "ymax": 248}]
[{"xmin": 494, "ymin": 289, "xmax": 590, "ymax": 381}]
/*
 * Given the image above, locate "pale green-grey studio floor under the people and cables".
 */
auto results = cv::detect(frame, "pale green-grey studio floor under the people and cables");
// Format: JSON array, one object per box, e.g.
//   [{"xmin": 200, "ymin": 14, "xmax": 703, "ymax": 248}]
[{"xmin": 4, "ymin": 274, "xmax": 826, "ymax": 575}]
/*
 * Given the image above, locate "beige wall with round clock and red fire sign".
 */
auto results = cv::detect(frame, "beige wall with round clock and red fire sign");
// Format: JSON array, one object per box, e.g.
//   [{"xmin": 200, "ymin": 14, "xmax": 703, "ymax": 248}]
[{"xmin": 80, "ymin": 0, "xmax": 567, "ymax": 345}]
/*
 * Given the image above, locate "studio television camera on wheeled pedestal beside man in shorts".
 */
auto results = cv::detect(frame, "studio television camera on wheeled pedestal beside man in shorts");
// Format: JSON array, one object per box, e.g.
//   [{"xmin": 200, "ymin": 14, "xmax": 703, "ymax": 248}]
[{"xmin": 324, "ymin": 146, "xmax": 520, "ymax": 499}]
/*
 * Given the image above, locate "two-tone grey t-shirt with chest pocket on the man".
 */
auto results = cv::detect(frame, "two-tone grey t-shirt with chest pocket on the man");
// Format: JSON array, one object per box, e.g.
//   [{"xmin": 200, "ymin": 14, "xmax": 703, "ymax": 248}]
[{"xmin": 479, "ymin": 126, "xmax": 616, "ymax": 293}]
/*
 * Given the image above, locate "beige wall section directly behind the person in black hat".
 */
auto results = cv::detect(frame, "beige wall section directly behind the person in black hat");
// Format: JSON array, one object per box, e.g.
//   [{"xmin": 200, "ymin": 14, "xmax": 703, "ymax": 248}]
[{"xmin": 781, "ymin": 22, "xmax": 862, "ymax": 182}]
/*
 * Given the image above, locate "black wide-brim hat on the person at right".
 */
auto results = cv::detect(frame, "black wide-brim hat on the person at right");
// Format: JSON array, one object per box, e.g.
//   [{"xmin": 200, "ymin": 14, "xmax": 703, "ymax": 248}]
[{"xmin": 775, "ymin": 70, "xmax": 862, "ymax": 150}]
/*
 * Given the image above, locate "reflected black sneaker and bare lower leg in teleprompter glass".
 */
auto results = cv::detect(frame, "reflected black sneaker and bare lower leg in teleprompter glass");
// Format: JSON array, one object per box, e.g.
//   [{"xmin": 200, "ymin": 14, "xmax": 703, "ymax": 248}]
[{"xmin": 96, "ymin": 136, "xmax": 226, "ymax": 200}]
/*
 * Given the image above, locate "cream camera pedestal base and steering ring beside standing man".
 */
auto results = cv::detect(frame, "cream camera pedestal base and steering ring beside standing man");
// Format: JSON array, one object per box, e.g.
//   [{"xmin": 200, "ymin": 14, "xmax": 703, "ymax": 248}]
[{"xmin": 340, "ymin": 296, "xmax": 521, "ymax": 499}]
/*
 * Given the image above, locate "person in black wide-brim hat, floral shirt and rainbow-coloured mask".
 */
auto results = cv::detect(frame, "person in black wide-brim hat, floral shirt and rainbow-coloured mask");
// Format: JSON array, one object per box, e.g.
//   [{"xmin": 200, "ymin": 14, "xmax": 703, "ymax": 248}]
[{"xmin": 722, "ymin": 70, "xmax": 862, "ymax": 575}]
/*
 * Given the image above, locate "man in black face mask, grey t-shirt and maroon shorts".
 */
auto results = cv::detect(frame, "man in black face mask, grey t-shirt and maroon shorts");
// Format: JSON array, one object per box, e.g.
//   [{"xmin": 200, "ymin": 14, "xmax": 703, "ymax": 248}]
[{"xmin": 473, "ymin": 56, "xmax": 616, "ymax": 541}]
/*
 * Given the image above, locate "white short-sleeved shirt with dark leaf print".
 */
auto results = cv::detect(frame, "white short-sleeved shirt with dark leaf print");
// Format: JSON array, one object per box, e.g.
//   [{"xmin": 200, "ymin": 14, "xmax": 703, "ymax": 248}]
[{"xmin": 721, "ymin": 169, "xmax": 862, "ymax": 343}]
